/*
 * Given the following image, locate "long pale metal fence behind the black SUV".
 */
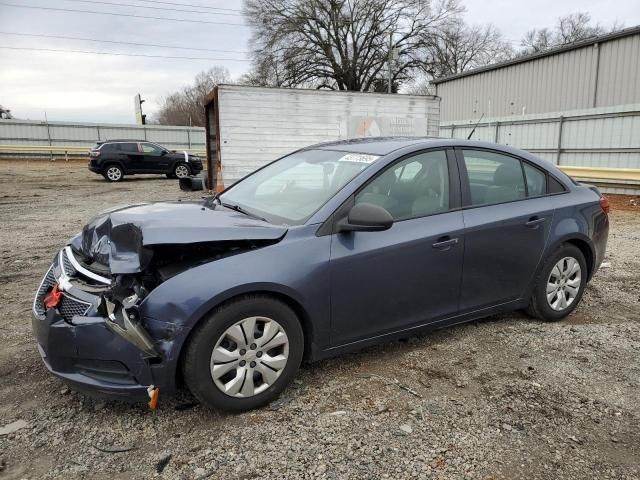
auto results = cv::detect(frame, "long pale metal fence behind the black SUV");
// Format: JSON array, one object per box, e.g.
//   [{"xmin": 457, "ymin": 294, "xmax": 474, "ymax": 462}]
[{"xmin": 0, "ymin": 120, "xmax": 205, "ymax": 158}]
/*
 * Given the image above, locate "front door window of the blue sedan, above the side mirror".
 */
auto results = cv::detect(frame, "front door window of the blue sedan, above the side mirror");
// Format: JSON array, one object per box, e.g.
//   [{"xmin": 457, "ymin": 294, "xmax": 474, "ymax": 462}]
[{"xmin": 355, "ymin": 150, "xmax": 449, "ymax": 220}]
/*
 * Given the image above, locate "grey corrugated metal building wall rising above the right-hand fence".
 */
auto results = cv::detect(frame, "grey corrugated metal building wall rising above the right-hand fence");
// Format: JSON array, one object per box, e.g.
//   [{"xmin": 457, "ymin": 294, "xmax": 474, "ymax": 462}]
[{"xmin": 437, "ymin": 29, "xmax": 640, "ymax": 122}]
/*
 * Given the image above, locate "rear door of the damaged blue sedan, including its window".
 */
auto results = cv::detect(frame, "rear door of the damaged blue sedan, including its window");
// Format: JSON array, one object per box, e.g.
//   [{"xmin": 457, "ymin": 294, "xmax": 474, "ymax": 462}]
[{"xmin": 456, "ymin": 149, "xmax": 553, "ymax": 313}]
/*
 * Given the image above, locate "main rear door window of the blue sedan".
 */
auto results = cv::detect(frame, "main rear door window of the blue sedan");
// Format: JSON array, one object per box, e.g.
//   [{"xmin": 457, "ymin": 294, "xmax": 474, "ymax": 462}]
[{"xmin": 462, "ymin": 150, "xmax": 526, "ymax": 205}]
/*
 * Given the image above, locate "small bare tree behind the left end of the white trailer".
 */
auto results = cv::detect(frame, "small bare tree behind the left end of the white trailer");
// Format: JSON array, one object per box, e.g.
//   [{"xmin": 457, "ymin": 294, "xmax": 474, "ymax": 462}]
[{"xmin": 155, "ymin": 67, "xmax": 231, "ymax": 127}]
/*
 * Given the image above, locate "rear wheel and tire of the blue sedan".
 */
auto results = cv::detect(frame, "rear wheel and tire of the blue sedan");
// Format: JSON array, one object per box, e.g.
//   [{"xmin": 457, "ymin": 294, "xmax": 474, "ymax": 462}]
[{"xmin": 527, "ymin": 244, "xmax": 588, "ymax": 322}]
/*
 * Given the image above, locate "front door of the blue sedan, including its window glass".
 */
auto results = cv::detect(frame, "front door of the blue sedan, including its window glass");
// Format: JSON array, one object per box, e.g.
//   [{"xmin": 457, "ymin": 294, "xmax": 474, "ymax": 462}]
[{"xmin": 329, "ymin": 150, "xmax": 465, "ymax": 346}]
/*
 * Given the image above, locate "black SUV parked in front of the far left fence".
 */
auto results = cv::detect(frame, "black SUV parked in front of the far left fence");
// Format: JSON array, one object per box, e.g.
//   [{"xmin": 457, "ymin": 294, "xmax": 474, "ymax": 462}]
[{"xmin": 89, "ymin": 140, "xmax": 202, "ymax": 182}]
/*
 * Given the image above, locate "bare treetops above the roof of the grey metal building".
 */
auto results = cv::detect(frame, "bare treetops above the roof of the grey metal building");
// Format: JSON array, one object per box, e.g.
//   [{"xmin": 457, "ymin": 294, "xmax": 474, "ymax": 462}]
[{"xmin": 520, "ymin": 12, "xmax": 623, "ymax": 54}]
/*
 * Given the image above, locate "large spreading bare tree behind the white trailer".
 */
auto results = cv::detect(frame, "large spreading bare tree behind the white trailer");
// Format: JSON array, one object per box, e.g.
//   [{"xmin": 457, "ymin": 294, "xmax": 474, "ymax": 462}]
[{"xmin": 244, "ymin": 0, "xmax": 463, "ymax": 91}]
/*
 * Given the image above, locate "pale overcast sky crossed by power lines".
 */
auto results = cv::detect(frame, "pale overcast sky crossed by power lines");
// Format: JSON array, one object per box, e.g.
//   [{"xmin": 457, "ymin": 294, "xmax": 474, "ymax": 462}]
[{"xmin": 0, "ymin": 0, "xmax": 640, "ymax": 123}]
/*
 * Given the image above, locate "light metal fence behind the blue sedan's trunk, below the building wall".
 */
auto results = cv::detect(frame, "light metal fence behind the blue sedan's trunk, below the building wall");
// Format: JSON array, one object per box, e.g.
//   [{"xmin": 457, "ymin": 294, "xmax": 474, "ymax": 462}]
[{"xmin": 440, "ymin": 104, "xmax": 640, "ymax": 193}]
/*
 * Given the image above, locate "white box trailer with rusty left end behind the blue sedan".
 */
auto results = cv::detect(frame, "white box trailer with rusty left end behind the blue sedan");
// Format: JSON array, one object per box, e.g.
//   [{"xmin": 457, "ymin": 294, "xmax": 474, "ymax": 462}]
[{"xmin": 205, "ymin": 85, "xmax": 440, "ymax": 190}]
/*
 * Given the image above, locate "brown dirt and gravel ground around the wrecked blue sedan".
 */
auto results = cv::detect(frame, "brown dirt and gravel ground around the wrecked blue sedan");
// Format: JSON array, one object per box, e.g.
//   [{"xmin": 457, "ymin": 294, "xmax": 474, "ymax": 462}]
[{"xmin": 0, "ymin": 162, "xmax": 640, "ymax": 480}]
